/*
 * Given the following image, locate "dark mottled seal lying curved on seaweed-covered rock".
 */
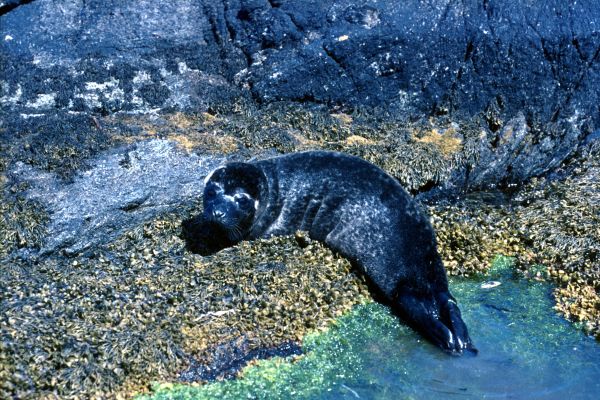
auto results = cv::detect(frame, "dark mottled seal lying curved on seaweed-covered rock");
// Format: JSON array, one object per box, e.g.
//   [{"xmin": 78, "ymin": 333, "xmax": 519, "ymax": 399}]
[{"xmin": 183, "ymin": 151, "xmax": 477, "ymax": 354}]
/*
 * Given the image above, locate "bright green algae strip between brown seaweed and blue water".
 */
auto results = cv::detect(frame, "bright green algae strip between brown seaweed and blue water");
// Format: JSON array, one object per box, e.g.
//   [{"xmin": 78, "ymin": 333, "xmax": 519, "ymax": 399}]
[{"xmin": 138, "ymin": 302, "xmax": 408, "ymax": 400}]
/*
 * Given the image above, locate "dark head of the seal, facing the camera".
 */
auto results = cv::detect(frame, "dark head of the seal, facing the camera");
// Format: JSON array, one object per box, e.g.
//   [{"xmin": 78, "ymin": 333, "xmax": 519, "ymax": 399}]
[{"xmin": 203, "ymin": 163, "xmax": 266, "ymax": 243}]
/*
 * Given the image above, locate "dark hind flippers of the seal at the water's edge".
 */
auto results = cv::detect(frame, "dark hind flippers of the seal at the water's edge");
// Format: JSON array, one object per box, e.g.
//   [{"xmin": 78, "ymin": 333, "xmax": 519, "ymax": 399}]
[{"xmin": 394, "ymin": 291, "xmax": 477, "ymax": 355}]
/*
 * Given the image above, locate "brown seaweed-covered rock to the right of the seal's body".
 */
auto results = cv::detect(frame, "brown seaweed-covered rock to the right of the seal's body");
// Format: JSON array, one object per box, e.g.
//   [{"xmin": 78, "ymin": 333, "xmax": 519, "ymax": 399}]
[{"xmin": 429, "ymin": 140, "xmax": 600, "ymax": 339}]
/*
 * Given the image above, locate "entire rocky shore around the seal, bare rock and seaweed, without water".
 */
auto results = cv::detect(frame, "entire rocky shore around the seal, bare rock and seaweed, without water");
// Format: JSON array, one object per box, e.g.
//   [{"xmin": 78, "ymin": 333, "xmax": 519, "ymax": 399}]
[{"xmin": 0, "ymin": 0, "xmax": 600, "ymax": 398}]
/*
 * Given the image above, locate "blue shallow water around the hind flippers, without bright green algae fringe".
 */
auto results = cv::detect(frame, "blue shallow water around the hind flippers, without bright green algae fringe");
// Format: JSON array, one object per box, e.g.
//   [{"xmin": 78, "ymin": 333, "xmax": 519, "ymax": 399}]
[{"xmin": 315, "ymin": 268, "xmax": 600, "ymax": 400}]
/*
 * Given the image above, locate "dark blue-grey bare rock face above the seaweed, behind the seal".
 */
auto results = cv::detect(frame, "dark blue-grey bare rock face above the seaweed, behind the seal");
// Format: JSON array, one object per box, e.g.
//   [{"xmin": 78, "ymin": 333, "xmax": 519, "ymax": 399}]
[{"xmin": 0, "ymin": 0, "xmax": 600, "ymax": 190}]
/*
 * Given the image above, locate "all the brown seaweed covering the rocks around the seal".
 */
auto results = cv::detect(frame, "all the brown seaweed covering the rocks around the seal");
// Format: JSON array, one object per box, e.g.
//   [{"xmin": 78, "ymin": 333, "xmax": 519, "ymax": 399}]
[{"xmin": 0, "ymin": 103, "xmax": 600, "ymax": 398}]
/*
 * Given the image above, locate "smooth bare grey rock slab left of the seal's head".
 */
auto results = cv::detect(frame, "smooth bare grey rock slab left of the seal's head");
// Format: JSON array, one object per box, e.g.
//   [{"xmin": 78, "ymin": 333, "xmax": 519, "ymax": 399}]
[{"xmin": 12, "ymin": 140, "xmax": 223, "ymax": 254}]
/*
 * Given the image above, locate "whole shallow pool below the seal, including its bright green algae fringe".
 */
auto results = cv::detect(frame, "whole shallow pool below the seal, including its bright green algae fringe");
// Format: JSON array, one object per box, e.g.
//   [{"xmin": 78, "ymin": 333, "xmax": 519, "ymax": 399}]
[{"xmin": 145, "ymin": 263, "xmax": 600, "ymax": 400}]
